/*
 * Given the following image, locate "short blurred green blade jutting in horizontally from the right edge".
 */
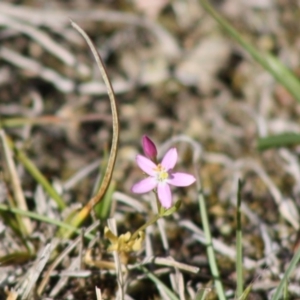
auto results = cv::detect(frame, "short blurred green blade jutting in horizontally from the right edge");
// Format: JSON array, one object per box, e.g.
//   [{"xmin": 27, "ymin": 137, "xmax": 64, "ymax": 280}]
[{"xmin": 257, "ymin": 132, "xmax": 300, "ymax": 151}]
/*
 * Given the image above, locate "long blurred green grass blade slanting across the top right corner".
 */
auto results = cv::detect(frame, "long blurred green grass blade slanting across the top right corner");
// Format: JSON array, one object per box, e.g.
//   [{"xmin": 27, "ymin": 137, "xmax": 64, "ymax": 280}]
[{"xmin": 200, "ymin": 0, "xmax": 300, "ymax": 102}]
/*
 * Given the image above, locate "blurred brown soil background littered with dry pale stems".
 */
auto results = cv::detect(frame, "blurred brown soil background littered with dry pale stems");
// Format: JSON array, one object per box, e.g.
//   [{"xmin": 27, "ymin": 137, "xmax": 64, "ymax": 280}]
[{"xmin": 0, "ymin": 0, "xmax": 300, "ymax": 300}]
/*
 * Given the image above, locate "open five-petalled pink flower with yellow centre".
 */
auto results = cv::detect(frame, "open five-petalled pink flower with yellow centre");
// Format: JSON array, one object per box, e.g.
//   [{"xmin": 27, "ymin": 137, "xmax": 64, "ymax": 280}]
[{"xmin": 131, "ymin": 148, "xmax": 196, "ymax": 208}]
